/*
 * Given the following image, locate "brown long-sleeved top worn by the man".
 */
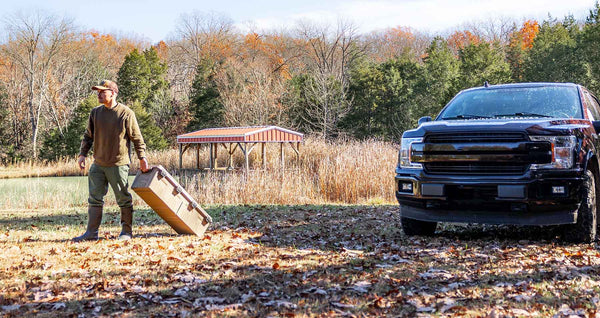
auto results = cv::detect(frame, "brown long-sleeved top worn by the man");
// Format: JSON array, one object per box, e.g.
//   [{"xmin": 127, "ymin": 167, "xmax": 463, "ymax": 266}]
[{"xmin": 79, "ymin": 103, "xmax": 146, "ymax": 167}]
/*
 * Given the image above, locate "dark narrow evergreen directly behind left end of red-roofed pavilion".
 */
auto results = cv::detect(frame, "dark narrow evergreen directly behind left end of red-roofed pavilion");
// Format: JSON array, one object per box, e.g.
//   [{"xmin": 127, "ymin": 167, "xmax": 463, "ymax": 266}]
[{"xmin": 188, "ymin": 60, "xmax": 225, "ymax": 130}]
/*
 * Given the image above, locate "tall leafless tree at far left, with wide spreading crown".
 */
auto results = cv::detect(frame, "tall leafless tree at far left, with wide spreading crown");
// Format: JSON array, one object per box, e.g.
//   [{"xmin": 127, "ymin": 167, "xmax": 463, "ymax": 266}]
[{"xmin": 2, "ymin": 11, "xmax": 72, "ymax": 158}]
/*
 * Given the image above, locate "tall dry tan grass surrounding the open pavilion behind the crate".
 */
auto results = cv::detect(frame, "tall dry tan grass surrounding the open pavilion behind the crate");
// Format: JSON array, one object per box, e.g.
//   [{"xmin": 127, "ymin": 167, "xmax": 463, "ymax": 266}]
[{"xmin": 0, "ymin": 138, "xmax": 404, "ymax": 207}]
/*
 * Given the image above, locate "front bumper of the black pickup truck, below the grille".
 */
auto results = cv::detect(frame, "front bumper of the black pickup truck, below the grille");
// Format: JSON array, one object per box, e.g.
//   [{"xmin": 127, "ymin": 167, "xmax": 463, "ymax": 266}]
[{"xmin": 396, "ymin": 171, "xmax": 583, "ymax": 225}]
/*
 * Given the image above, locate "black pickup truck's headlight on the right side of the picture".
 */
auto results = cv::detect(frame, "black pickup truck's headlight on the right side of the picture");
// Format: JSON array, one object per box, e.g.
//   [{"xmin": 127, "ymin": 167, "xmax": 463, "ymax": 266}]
[{"xmin": 529, "ymin": 136, "xmax": 577, "ymax": 169}]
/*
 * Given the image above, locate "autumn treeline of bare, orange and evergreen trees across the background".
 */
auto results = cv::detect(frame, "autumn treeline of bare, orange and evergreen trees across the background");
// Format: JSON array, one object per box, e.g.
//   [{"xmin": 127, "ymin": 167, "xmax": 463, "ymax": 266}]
[{"xmin": 0, "ymin": 3, "xmax": 600, "ymax": 163}]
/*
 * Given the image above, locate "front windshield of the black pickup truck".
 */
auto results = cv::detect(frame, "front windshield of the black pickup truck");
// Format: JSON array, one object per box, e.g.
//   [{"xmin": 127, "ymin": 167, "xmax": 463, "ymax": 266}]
[{"xmin": 438, "ymin": 86, "xmax": 583, "ymax": 120}]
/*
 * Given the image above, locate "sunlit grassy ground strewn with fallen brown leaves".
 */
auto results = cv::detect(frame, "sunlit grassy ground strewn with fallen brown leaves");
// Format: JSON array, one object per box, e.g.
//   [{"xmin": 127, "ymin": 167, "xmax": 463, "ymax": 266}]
[{"xmin": 0, "ymin": 206, "xmax": 600, "ymax": 317}]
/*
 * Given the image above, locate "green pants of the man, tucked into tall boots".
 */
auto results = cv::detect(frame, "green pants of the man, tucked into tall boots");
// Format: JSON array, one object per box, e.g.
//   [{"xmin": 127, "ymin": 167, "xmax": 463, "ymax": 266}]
[{"xmin": 88, "ymin": 164, "xmax": 133, "ymax": 208}]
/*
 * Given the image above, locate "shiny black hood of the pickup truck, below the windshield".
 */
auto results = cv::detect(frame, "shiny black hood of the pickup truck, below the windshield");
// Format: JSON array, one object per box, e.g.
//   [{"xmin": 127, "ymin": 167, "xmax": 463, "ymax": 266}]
[{"xmin": 403, "ymin": 118, "xmax": 595, "ymax": 138}]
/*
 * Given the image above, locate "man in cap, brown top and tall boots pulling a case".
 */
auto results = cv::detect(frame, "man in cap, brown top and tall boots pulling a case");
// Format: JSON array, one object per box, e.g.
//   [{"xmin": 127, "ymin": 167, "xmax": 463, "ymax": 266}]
[{"xmin": 73, "ymin": 80, "xmax": 148, "ymax": 242}]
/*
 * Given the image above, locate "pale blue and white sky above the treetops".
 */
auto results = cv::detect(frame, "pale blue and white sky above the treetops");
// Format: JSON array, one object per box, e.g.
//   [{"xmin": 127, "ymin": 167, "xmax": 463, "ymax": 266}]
[{"xmin": 0, "ymin": 0, "xmax": 595, "ymax": 43}]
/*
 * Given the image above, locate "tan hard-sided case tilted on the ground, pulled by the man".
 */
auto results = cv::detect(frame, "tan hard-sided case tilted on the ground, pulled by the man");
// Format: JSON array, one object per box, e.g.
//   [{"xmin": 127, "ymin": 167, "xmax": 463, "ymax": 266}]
[{"xmin": 131, "ymin": 166, "xmax": 212, "ymax": 236}]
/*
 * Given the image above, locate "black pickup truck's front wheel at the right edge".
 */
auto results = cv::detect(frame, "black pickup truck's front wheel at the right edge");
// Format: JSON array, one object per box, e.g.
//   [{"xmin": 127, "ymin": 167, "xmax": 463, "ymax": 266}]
[{"xmin": 564, "ymin": 170, "xmax": 597, "ymax": 243}]
